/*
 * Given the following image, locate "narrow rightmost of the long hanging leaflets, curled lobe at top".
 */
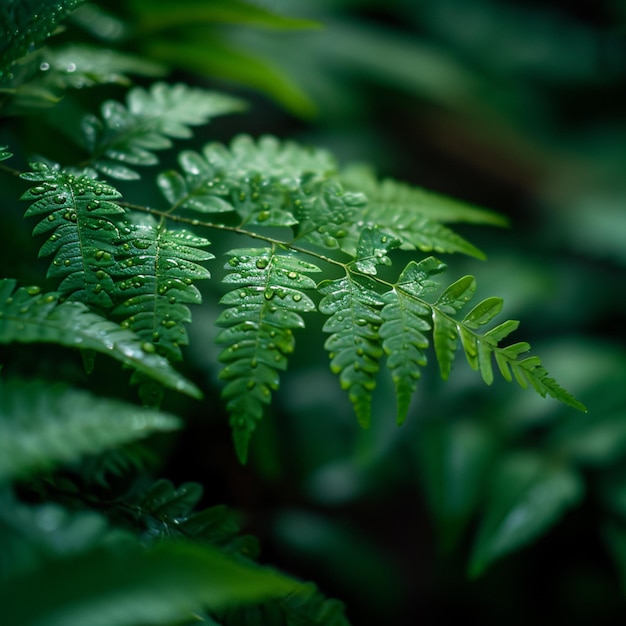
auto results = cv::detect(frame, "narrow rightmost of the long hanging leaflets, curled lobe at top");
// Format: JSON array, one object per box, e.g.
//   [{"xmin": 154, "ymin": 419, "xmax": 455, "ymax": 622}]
[{"xmin": 380, "ymin": 257, "xmax": 445, "ymax": 424}]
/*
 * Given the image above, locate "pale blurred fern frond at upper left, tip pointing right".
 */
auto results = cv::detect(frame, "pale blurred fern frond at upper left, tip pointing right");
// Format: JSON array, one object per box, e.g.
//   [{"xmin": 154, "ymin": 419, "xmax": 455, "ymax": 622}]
[{"xmin": 82, "ymin": 83, "xmax": 243, "ymax": 180}]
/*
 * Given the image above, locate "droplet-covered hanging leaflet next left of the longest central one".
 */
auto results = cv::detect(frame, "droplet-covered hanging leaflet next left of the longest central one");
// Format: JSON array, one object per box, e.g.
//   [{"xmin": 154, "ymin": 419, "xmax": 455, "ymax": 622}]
[{"xmin": 113, "ymin": 215, "xmax": 214, "ymax": 361}]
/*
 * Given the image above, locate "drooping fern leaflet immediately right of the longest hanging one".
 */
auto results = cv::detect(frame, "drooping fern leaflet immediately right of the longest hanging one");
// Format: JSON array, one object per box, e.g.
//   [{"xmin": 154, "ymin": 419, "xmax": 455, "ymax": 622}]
[{"xmin": 319, "ymin": 275, "xmax": 385, "ymax": 427}]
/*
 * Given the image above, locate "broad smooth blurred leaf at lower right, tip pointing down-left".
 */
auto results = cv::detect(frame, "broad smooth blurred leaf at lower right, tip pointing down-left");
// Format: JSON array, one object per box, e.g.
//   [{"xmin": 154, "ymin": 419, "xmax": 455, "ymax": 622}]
[{"xmin": 469, "ymin": 453, "xmax": 584, "ymax": 576}]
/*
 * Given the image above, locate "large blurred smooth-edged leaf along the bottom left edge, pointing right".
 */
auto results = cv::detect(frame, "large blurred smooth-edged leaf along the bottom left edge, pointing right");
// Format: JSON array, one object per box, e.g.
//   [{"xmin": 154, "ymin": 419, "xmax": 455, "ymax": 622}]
[{"xmin": 0, "ymin": 537, "xmax": 301, "ymax": 626}]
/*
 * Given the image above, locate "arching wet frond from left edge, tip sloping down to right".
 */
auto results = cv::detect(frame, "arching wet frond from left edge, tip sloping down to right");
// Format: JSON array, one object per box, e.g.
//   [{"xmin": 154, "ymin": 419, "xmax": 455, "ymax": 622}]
[{"xmin": 0, "ymin": 279, "xmax": 202, "ymax": 397}]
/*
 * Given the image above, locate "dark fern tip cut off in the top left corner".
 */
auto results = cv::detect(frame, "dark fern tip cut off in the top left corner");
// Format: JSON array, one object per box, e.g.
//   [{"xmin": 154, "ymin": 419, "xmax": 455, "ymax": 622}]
[{"xmin": 0, "ymin": 0, "xmax": 84, "ymax": 78}]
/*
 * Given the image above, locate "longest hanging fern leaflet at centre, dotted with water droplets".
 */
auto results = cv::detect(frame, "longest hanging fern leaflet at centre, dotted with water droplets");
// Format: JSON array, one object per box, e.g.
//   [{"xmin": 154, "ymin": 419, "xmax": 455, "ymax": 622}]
[{"xmin": 216, "ymin": 248, "xmax": 320, "ymax": 462}]
